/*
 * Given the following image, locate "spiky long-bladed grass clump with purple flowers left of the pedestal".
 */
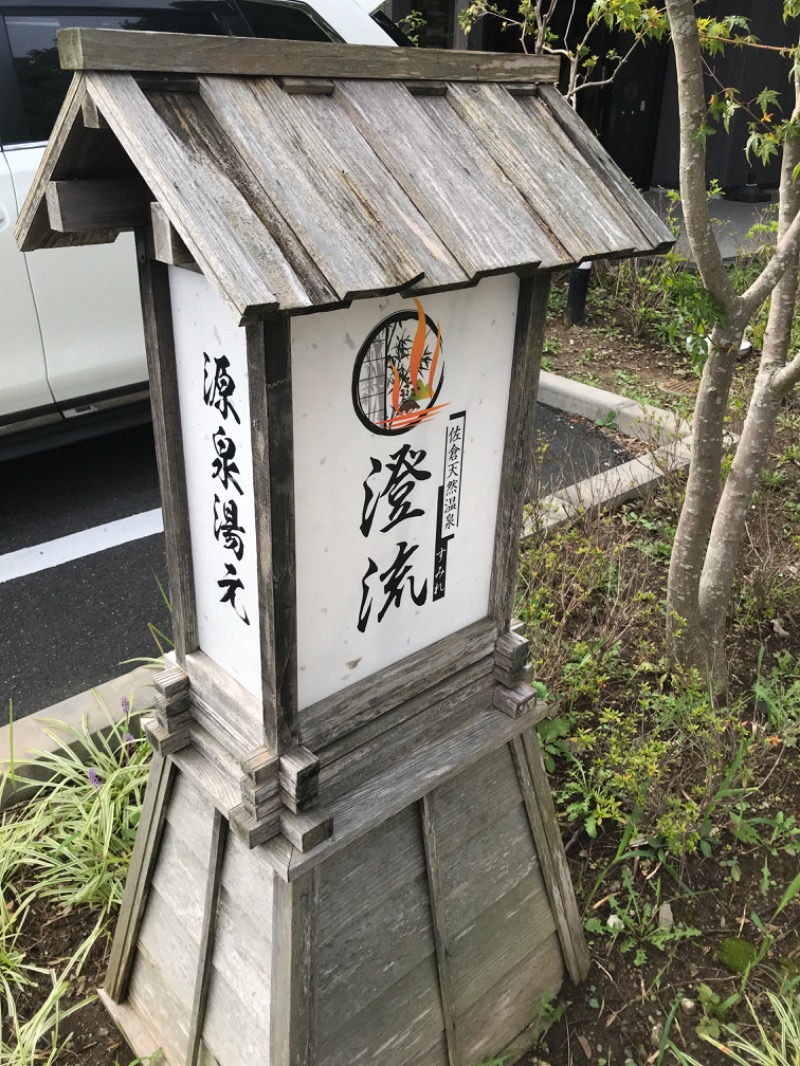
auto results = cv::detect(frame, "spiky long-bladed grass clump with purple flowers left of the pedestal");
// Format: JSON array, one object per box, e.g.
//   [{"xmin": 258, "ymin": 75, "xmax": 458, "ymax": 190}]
[{"xmin": 0, "ymin": 699, "xmax": 149, "ymax": 1066}]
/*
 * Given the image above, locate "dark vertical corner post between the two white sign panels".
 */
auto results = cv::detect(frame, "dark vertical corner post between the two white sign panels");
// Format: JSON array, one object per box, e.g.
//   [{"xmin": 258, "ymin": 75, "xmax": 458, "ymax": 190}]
[{"xmin": 247, "ymin": 317, "xmax": 298, "ymax": 756}]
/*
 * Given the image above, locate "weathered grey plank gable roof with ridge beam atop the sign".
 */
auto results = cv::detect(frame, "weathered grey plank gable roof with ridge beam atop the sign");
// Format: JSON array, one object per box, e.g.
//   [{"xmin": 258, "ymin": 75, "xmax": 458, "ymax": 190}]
[{"xmin": 17, "ymin": 30, "xmax": 673, "ymax": 322}]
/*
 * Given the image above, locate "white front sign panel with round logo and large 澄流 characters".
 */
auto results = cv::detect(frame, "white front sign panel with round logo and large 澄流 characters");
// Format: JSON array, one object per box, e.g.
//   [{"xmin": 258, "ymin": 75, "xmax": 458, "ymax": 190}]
[{"xmin": 291, "ymin": 276, "xmax": 519, "ymax": 708}]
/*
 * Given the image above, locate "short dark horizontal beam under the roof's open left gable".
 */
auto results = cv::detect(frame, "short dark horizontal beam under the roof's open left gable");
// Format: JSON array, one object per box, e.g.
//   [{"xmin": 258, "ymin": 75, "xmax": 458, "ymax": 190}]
[{"xmin": 45, "ymin": 178, "xmax": 153, "ymax": 233}]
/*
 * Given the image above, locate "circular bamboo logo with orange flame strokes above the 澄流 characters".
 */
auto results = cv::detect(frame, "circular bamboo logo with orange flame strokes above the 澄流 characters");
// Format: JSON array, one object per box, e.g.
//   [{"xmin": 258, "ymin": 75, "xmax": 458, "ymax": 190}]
[{"xmin": 353, "ymin": 298, "xmax": 446, "ymax": 435}]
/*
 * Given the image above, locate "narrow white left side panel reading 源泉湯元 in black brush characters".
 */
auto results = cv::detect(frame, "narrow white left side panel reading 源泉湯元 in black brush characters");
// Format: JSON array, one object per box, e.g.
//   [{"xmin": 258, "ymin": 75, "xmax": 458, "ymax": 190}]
[{"xmin": 170, "ymin": 268, "xmax": 261, "ymax": 698}]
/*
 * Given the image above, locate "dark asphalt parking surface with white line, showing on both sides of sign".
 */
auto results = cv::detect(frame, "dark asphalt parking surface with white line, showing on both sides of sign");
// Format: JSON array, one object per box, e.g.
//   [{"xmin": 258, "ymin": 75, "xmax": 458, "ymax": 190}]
[{"xmin": 0, "ymin": 405, "xmax": 629, "ymax": 725}]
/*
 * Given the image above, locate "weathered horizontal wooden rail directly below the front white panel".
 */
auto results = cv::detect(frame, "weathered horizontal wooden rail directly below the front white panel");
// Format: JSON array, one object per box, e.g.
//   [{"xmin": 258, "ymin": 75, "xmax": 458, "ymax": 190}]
[{"xmin": 299, "ymin": 619, "xmax": 497, "ymax": 752}]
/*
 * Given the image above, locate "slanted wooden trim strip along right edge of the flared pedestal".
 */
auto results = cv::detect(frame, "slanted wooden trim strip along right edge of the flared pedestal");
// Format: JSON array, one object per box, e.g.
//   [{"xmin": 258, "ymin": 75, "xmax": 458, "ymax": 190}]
[{"xmin": 511, "ymin": 729, "xmax": 591, "ymax": 984}]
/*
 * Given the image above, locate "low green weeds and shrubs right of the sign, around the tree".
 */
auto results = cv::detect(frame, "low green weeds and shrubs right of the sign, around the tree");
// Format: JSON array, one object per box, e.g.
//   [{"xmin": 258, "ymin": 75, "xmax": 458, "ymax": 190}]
[{"xmin": 516, "ymin": 454, "xmax": 800, "ymax": 1053}]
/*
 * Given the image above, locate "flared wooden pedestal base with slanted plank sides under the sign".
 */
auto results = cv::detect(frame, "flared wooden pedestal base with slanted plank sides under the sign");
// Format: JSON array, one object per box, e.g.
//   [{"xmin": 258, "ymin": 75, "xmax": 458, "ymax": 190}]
[{"xmin": 103, "ymin": 710, "xmax": 587, "ymax": 1066}]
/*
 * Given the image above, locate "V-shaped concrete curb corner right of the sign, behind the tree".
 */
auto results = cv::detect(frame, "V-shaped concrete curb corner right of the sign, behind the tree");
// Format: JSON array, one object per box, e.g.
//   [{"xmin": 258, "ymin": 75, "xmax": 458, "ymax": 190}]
[{"xmin": 523, "ymin": 371, "xmax": 691, "ymax": 537}]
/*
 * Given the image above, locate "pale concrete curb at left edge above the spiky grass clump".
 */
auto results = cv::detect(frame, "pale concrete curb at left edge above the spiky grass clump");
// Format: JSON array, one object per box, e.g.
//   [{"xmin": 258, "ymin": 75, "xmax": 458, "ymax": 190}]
[{"xmin": 0, "ymin": 666, "xmax": 156, "ymax": 810}]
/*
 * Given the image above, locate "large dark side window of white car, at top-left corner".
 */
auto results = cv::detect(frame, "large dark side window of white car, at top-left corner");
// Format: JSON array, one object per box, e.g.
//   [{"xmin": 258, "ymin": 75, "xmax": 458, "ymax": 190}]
[{"xmin": 5, "ymin": 9, "xmax": 228, "ymax": 143}]
